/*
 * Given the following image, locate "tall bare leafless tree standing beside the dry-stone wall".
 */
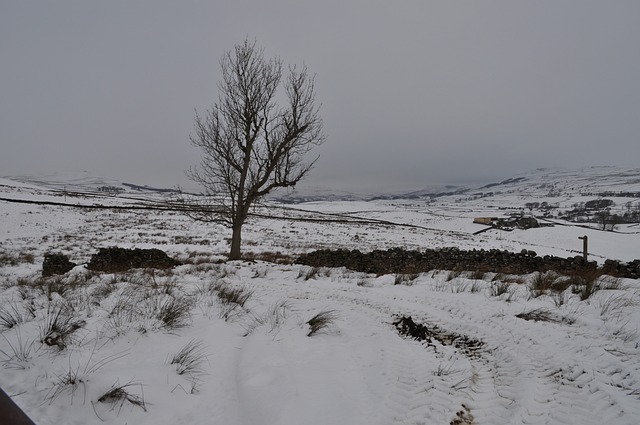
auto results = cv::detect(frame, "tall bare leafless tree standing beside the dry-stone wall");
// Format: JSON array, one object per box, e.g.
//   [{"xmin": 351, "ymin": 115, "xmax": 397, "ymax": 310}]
[{"xmin": 187, "ymin": 40, "xmax": 325, "ymax": 260}]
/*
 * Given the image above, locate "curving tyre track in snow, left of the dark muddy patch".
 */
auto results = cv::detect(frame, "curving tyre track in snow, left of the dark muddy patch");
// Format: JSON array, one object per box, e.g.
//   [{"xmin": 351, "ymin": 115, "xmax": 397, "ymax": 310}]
[{"xmin": 245, "ymin": 274, "xmax": 469, "ymax": 425}]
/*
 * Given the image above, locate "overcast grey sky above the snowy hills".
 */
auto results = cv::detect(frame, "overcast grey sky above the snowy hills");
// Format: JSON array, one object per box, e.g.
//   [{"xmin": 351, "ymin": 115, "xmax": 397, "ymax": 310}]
[{"xmin": 0, "ymin": 0, "xmax": 640, "ymax": 190}]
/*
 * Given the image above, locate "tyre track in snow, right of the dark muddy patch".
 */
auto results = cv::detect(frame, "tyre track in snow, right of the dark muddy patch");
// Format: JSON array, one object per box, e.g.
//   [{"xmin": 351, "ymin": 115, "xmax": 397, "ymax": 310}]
[{"xmin": 384, "ymin": 284, "xmax": 637, "ymax": 424}]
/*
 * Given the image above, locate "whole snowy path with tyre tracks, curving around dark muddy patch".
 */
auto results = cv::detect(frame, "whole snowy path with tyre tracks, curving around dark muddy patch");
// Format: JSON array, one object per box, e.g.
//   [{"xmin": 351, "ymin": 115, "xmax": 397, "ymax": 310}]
[{"xmin": 240, "ymin": 264, "xmax": 640, "ymax": 424}]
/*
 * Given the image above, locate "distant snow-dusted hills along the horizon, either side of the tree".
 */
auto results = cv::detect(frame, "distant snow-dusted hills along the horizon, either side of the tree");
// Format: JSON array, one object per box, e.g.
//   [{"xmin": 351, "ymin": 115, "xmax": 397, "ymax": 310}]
[{"xmin": 5, "ymin": 166, "xmax": 640, "ymax": 207}]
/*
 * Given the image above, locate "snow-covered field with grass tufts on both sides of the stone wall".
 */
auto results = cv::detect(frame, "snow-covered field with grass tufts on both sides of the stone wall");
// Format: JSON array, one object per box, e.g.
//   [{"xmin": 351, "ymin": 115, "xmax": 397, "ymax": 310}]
[{"xmin": 0, "ymin": 174, "xmax": 640, "ymax": 425}]
